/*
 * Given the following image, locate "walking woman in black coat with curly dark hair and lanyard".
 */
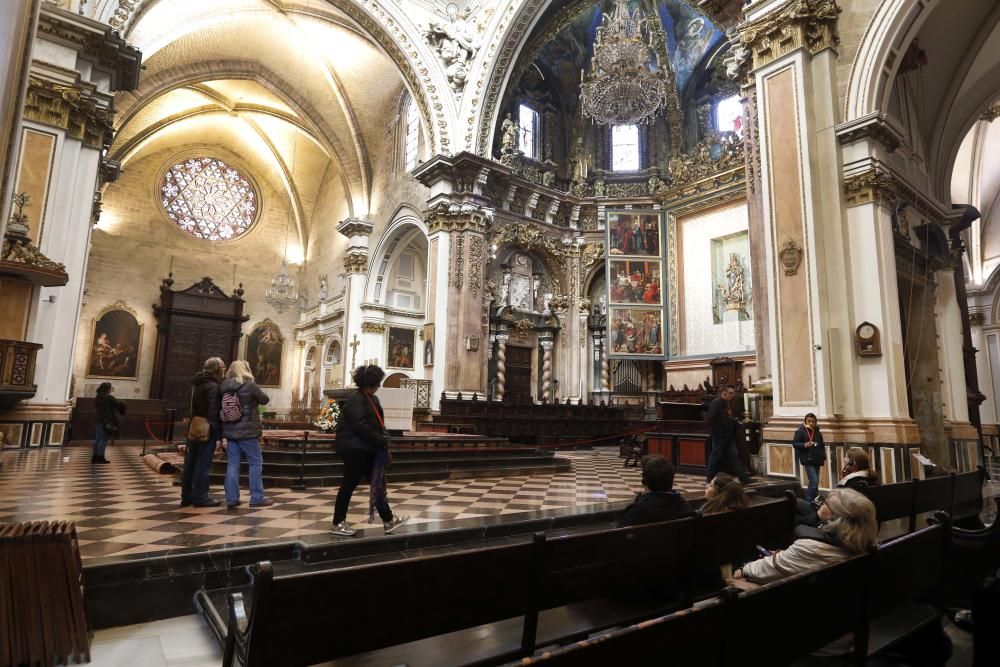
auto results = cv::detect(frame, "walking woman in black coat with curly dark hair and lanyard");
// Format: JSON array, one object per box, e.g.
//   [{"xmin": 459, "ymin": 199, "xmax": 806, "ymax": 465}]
[{"xmin": 330, "ymin": 365, "xmax": 409, "ymax": 537}]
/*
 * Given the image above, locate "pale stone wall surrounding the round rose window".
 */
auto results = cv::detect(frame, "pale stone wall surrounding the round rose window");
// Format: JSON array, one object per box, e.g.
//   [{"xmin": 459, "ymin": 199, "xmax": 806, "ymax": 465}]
[{"xmin": 73, "ymin": 147, "xmax": 300, "ymax": 410}]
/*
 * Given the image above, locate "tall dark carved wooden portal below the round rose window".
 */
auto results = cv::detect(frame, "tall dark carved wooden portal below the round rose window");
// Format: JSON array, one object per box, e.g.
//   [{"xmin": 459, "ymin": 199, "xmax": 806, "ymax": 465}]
[{"xmin": 150, "ymin": 277, "xmax": 249, "ymax": 416}]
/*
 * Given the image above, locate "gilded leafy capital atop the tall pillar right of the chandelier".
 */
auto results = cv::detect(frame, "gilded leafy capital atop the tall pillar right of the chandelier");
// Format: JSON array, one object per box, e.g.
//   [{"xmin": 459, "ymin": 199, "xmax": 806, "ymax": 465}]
[{"xmin": 737, "ymin": 0, "xmax": 841, "ymax": 70}]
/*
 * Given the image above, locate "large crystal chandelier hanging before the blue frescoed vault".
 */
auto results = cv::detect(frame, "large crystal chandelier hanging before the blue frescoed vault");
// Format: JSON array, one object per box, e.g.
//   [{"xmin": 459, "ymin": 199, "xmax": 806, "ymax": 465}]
[{"xmin": 580, "ymin": 0, "xmax": 668, "ymax": 125}]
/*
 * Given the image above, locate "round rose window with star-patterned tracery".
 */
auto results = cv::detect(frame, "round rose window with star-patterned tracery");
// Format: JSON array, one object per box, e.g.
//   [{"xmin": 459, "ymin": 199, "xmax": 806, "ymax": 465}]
[{"xmin": 161, "ymin": 157, "xmax": 257, "ymax": 241}]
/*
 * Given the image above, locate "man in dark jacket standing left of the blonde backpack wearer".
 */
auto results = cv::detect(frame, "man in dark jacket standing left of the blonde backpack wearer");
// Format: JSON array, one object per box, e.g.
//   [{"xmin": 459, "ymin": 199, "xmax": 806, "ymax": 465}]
[{"xmin": 181, "ymin": 357, "xmax": 226, "ymax": 507}]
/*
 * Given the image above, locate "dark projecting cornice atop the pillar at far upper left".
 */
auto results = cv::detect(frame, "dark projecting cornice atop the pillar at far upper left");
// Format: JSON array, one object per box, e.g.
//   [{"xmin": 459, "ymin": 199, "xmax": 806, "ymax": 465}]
[{"xmin": 38, "ymin": 2, "xmax": 142, "ymax": 91}]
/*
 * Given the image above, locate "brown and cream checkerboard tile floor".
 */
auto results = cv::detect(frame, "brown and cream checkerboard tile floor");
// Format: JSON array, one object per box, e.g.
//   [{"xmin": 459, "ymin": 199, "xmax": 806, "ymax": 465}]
[{"xmin": 0, "ymin": 447, "xmax": 704, "ymax": 559}]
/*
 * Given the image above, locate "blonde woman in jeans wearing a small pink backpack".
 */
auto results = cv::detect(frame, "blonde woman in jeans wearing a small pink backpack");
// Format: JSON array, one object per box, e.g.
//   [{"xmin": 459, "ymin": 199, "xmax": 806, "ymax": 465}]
[{"xmin": 219, "ymin": 359, "xmax": 274, "ymax": 509}]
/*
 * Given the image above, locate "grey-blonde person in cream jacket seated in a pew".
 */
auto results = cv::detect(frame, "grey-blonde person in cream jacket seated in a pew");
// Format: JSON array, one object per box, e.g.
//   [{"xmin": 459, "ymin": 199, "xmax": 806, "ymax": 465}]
[{"xmin": 726, "ymin": 489, "xmax": 878, "ymax": 656}]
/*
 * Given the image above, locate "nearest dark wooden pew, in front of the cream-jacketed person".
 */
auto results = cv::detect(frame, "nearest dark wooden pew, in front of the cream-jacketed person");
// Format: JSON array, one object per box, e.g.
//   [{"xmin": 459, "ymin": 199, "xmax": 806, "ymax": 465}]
[{"xmin": 512, "ymin": 520, "xmax": 949, "ymax": 667}]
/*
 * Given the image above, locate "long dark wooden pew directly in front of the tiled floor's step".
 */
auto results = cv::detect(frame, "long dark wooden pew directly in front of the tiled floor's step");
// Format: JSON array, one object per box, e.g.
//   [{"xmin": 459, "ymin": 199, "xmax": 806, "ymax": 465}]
[{"xmin": 223, "ymin": 497, "xmax": 794, "ymax": 667}]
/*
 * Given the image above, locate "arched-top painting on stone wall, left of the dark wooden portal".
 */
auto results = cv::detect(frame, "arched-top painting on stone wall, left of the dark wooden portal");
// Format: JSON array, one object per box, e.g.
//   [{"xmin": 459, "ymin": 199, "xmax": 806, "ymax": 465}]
[{"xmin": 87, "ymin": 302, "xmax": 142, "ymax": 380}]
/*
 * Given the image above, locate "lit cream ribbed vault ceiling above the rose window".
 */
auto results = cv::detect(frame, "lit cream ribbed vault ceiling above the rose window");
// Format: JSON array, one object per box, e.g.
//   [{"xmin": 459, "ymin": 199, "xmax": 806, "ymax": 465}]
[{"xmin": 105, "ymin": 0, "xmax": 404, "ymax": 250}]
